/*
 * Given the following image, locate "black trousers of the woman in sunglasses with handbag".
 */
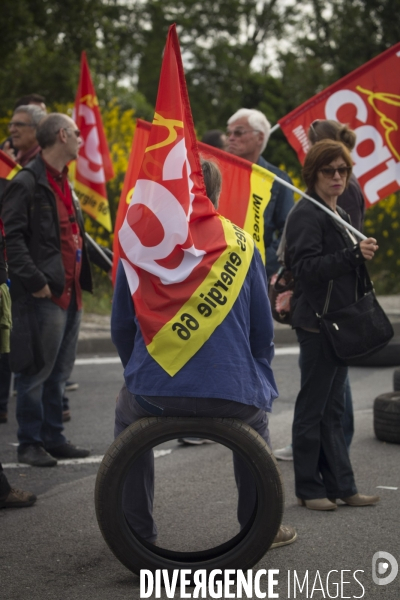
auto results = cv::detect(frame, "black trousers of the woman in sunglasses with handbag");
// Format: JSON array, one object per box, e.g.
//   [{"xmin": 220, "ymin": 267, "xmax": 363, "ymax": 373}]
[{"xmin": 293, "ymin": 329, "xmax": 357, "ymax": 500}]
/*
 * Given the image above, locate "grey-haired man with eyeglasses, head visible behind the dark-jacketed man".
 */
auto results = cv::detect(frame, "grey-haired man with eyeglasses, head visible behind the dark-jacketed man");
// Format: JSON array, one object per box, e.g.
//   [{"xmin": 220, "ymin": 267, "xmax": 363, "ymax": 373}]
[{"xmin": 3, "ymin": 104, "xmax": 46, "ymax": 167}]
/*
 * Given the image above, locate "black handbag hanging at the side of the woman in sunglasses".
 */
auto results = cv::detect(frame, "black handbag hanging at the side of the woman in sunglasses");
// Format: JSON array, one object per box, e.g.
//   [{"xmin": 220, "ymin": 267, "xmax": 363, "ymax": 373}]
[{"xmin": 317, "ymin": 277, "xmax": 394, "ymax": 363}]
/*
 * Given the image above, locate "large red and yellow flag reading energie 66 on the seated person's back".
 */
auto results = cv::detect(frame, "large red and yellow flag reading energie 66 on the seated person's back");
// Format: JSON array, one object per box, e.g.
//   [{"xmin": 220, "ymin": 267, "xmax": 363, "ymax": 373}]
[{"xmin": 118, "ymin": 25, "xmax": 254, "ymax": 376}]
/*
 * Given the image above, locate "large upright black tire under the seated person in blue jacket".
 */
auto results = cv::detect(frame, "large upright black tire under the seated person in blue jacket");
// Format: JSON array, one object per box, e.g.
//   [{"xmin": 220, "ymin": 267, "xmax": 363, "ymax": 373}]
[{"xmin": 95, "ymin": 417, "xmax": 284, "ymax": 574}]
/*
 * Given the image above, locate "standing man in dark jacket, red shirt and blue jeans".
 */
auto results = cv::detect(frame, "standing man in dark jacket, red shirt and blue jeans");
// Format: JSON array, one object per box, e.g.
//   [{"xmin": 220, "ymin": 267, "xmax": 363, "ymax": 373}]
[{"xmin": 2, "ymin": 113, "xmax": 106, "ymax": 467}]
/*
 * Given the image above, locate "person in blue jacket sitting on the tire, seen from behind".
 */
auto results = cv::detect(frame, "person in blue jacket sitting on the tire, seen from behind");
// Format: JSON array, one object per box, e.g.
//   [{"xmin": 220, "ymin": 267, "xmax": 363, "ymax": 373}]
[{"xmin": 111, "ymin": 161, "xmax": 297, "ymax": 548}]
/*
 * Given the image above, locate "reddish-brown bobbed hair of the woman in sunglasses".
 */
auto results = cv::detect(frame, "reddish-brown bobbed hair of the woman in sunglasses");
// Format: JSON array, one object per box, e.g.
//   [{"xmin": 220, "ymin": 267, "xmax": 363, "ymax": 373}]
[{"xmin": 303, "ymin": 140, "xmax": 353, "ymax": 192}]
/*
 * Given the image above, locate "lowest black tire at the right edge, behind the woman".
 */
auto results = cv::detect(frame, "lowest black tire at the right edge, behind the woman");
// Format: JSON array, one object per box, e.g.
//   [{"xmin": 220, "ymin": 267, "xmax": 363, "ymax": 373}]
[{"xmin": 374, "ymin": 391, "xmax": 400, "ymax": 444}]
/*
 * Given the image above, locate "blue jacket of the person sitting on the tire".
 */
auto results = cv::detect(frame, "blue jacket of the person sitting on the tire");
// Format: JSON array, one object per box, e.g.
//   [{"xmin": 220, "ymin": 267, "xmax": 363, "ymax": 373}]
[{"xmin": 111, "ymin": 249, "xmax": 278, "ymax": 411}]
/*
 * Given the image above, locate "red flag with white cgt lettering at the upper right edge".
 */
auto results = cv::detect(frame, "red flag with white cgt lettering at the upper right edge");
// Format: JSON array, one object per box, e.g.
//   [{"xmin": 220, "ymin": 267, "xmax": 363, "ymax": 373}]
[{"xmin": 279, "ymin": 42, "xmax": 400, "ymax": 206}]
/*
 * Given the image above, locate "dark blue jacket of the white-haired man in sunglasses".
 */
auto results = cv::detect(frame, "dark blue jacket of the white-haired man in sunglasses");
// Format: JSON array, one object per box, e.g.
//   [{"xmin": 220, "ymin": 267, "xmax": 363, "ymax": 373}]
[{"xmin": 257, "ymin": 156, "xmax": 294, "ymax": 277}]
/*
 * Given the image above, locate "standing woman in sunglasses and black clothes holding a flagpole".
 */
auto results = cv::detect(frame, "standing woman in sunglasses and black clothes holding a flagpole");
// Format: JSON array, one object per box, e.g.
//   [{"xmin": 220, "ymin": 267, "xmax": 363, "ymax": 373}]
[{"xmin": 286, "ymin": 140, "xmax": 379, "ymax": 510}]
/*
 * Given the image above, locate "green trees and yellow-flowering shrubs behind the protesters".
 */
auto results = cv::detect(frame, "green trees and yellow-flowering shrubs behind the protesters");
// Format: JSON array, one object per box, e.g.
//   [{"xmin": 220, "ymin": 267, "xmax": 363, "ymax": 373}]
[{"xmin": 0, "ymin": 0, "xmax": 400, "ymax": 292}]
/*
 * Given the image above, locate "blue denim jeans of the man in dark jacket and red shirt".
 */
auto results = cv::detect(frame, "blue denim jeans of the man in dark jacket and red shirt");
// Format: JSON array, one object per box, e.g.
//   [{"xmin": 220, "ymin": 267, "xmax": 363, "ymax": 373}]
[{"xmin": 17, "ymin": 298, "xmax": 82, "ymax": 448}]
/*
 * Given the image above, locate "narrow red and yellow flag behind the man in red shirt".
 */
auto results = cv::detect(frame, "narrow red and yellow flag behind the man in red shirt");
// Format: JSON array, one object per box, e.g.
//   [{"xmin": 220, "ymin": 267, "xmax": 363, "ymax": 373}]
[{"xmin": 71, "ymin": 52, "xmax": 114, "ymax": 231}]
